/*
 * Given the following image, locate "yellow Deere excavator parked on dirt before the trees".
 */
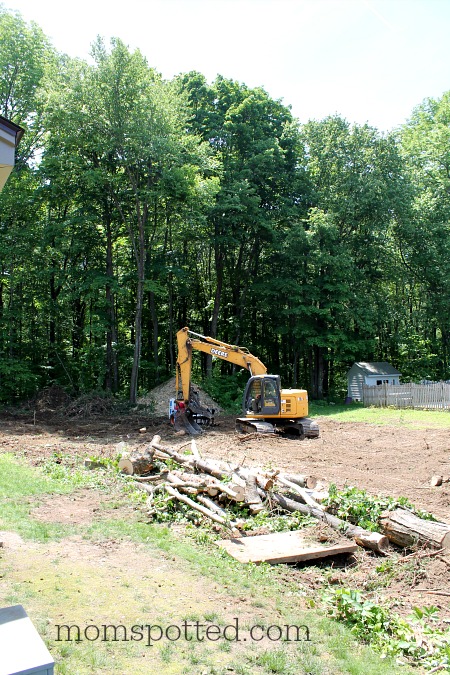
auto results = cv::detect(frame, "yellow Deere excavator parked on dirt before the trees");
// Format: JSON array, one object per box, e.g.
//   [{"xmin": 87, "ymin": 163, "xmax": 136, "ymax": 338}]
[{"xmin": 173, "ymin": 328, "xmax": 319, "ymax": 439}]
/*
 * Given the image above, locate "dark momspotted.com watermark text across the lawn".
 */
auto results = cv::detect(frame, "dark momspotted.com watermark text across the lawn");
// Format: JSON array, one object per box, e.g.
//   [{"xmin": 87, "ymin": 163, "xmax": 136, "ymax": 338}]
[{"xmin": 55, "ymin": 617, "xmax": 311, "ymax": 647}]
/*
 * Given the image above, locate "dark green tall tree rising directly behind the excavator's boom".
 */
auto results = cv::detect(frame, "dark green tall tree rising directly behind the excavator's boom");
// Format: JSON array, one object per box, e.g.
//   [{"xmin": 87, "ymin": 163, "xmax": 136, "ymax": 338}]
[{"xmin": 177, "ymin": 73, "xmax": 302, "ymax": 372}]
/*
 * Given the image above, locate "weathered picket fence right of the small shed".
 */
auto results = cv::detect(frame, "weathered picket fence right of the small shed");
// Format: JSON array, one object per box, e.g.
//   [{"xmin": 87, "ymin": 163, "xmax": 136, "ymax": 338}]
[{"xmin": 363, "ymin": 382, "xmax": 450, "ymax": 410}]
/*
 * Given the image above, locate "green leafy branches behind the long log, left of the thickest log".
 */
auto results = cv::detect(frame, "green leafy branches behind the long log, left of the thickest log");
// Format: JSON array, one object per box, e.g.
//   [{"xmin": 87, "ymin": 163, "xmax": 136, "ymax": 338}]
[{"xmin": 324, "ymin": 483, "xmax": 435, "ymax": 532}]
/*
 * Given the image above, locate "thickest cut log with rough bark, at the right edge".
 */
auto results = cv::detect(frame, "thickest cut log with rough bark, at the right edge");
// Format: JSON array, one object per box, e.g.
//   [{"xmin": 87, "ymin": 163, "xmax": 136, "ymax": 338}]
[{"xmin": 380, "ymin": 509, "xmax": 450, "ymax": 551}]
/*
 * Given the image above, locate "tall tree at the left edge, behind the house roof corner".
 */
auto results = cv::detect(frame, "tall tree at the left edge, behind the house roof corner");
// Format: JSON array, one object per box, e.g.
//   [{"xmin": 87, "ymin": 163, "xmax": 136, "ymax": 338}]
[{"xmin": 0, "ymin": 6, "xmax": 56, "ymax": 397}]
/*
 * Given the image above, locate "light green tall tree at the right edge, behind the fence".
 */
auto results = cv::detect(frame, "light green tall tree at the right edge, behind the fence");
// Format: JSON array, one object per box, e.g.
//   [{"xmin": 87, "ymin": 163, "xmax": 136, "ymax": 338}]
[{"xmin": 396, "ymin": 92, "xmax": 450, "ymax": 378}]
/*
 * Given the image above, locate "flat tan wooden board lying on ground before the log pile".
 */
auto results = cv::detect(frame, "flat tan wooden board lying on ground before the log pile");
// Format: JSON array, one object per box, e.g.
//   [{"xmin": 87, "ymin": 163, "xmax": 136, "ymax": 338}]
[{"xmin": 216, "ymin": 531, "xmax": 358, "ymax": 564}]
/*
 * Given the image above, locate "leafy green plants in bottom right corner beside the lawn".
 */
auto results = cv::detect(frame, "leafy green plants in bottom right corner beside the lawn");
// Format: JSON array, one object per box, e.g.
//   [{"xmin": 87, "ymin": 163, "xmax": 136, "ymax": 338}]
[{"xmin": 327, "ymin": 588, "xmax": 450, "ymax": 671}]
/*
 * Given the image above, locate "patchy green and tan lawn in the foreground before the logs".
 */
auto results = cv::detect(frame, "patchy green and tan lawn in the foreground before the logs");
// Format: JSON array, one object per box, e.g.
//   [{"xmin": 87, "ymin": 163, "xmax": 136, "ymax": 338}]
[{"xmin": 0, "ymin": 455, "xmax": 418, "ymax": 675}]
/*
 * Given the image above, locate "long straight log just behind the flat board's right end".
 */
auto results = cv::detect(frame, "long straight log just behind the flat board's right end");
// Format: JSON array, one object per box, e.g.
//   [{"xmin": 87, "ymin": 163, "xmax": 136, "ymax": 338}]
[{"xmin": 264, "ymin": 492, "xmax": 389, "ymax": 555}]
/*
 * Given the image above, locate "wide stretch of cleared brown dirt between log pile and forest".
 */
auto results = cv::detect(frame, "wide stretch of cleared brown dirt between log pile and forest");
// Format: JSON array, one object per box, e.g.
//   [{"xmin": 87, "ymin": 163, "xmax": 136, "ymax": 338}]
[{"xmin": 0, "ymin": 406, "xmax": 450, "ymax": 521}]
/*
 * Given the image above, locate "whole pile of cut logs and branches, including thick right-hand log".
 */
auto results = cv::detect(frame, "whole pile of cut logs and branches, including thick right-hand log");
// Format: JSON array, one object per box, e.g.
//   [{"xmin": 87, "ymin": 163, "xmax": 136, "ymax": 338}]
[{"xmin": 119, "ymin": 436, "xmax": 450, "ymax": 555}]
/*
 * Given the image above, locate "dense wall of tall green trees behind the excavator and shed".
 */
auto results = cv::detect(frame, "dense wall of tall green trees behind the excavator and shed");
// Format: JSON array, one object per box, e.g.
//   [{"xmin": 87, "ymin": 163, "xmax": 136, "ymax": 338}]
[{"xmin": 0, "ymin": 6, "xmax": 450, "ymax": 403}]
